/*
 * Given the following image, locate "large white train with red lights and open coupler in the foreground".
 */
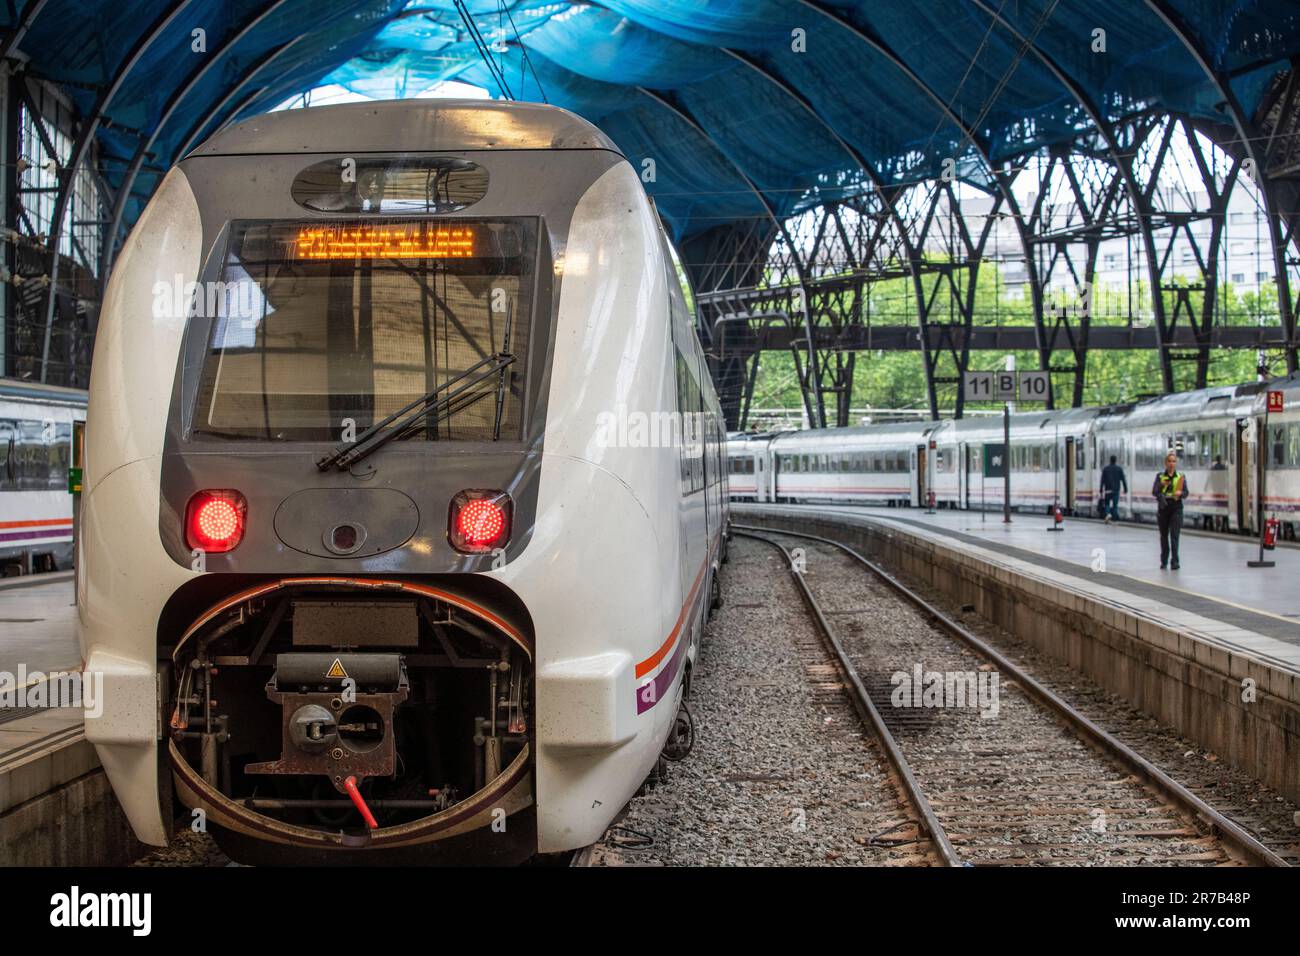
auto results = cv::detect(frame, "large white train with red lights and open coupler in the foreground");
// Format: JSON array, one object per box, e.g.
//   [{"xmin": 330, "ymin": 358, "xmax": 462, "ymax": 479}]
[{"xmin": 78, "ymin": 100, "xmax": 728, "ymax": 862}]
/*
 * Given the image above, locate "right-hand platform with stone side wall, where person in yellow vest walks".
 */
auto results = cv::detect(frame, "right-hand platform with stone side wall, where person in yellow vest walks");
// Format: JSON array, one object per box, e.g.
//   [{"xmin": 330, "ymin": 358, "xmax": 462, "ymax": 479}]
[{"xmin": 731, "ymin": 502, "xmax": 1300, "ymax": 800}]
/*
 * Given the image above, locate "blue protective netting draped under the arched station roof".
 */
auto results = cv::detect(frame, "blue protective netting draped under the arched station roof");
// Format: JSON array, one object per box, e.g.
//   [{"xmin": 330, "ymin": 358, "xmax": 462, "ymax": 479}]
[{"xmin": 0, "ymin": 0, "xmax": 1300, "ymax": 244}]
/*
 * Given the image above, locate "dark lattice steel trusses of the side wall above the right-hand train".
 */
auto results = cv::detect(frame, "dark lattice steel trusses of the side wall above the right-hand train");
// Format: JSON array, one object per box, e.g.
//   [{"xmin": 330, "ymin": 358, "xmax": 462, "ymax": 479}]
[{"xmin": 697, "ymin": 100, "xmax": 1297, "ymax": 428}]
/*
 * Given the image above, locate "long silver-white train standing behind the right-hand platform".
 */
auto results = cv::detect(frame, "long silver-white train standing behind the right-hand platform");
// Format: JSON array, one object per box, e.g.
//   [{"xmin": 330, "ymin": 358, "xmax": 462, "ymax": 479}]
[{"xmin": 727, "ymin": 376, "xmax": 1300, "ymax": 538}]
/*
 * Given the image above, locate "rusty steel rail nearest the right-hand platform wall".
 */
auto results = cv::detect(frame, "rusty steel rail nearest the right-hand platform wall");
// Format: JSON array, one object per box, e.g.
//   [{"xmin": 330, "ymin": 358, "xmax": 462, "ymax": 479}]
[{"xmin": 732, "ymin": 524, "xmax": 1290, "ymax": 866}]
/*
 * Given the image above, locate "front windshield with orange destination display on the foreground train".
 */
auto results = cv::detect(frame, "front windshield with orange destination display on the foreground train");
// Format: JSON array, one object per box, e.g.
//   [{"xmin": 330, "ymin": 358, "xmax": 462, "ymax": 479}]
[{"xmin": 192, "ymin": 219, "xmax": 537, "ymax": 442}]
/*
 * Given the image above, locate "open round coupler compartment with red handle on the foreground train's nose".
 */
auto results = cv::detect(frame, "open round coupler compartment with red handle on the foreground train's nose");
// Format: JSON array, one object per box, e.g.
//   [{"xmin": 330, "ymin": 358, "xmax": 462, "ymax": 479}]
[{"xmin": 168, "ymin": 578, "xmax": 536, "ymax": 858}]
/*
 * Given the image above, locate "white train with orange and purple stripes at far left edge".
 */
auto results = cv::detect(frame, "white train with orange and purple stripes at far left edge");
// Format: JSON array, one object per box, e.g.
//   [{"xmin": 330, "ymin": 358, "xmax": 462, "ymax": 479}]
[{"xmin": 0, "ymin": 378, "xmax": 86, "ymax": 574}]
